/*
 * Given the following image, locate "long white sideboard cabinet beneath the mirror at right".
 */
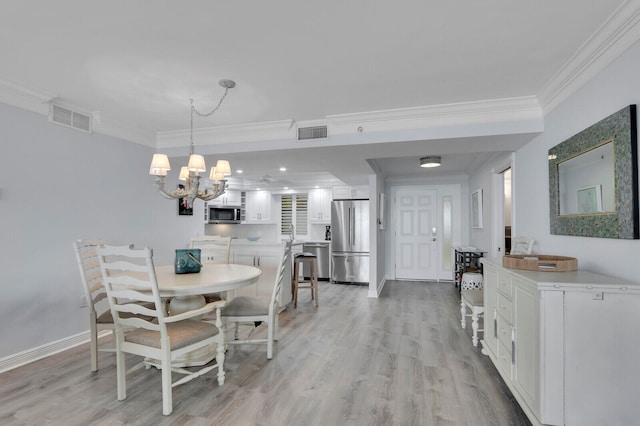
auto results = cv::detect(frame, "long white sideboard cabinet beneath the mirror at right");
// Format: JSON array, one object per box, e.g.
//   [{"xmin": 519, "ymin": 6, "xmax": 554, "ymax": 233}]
[{"xmin": 480, "ymin": 258, "xmax": 640, "ymax": 426}]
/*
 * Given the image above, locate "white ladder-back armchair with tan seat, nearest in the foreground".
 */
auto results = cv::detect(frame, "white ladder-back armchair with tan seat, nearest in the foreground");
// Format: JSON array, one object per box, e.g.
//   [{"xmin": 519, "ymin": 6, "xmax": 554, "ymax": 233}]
[{"xmin": 96, "ymin": 245, "xmax": 225, "ymax": 415}]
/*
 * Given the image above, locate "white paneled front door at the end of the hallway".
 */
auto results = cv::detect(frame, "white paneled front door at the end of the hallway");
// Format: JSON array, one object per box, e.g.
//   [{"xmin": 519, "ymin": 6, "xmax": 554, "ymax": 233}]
[{"xmin": 395, "ymin": 188, "xmax": 438, "ymax": 280}]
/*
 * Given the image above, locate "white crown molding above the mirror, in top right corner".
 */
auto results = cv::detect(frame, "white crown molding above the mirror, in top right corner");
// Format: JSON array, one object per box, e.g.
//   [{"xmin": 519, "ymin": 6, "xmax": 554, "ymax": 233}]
[{"xmin": 538, "ymin": 0, "xmax": 640, "ymax": 115}]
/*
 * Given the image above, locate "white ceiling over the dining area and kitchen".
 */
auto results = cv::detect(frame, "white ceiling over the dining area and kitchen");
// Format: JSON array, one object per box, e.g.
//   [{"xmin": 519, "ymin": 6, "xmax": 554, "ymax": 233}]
[{"xmin": 0, "ymin": 0, "xmax": 627, "ymax": 185}]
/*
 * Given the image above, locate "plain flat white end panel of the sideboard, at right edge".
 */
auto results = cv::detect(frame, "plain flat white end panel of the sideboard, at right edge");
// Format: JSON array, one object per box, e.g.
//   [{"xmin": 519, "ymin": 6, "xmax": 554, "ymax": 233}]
[{"xmin": 564, "ymin": 290, "xmax": 640, "ymax": 426}]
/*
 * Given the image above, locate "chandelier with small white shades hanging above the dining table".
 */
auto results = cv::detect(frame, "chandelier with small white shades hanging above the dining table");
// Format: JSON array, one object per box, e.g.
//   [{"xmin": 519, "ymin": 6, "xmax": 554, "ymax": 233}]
[{"xmin": 149, "ymin": 80, "xmax": 236, "ymax": 205}]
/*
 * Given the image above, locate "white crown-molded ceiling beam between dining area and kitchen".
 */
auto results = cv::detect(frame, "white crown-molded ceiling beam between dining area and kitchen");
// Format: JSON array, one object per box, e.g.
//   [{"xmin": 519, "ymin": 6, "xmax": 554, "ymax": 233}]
[{"xmin": 157, "ymin": 96, "xmax": 543, "ymax": 150}]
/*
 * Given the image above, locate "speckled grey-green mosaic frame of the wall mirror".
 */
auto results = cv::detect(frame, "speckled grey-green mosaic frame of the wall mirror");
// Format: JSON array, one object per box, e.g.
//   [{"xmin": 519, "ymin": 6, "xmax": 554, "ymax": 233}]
[{"xmin": 548, "ymin": 105, "xmax": 640, "ymax": 239}]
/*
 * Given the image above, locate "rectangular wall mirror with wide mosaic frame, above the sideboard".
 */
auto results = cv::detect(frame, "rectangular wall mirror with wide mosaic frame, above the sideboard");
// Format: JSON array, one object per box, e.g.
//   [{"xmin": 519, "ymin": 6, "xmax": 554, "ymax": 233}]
[{"xmin": 549, "ymin": 105, "xmax": 640, "ymax": 239}]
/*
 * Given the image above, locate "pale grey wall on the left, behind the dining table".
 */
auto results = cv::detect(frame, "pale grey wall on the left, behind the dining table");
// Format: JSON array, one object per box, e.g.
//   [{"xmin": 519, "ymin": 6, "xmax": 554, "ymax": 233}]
[{"xmin": 0, "ymin": 103, "xmax": 202, "ymax": 359}]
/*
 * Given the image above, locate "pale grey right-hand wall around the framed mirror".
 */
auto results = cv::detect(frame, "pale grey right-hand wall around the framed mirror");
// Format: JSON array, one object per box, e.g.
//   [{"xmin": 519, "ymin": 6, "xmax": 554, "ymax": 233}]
[{"xmin": 471, "ymin": 38, "xmax": 640, "ymax": 281}]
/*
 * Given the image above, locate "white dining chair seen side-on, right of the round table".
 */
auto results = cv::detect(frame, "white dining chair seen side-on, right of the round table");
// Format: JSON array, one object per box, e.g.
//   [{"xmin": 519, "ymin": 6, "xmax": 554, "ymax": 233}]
[{"xmin": 222, "ymin": 241, "xmax": 291, "ymax": 359}]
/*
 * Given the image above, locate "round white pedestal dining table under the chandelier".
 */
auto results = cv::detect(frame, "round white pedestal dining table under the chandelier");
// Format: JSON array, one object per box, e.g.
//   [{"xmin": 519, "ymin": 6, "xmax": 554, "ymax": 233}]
[{"xmin": 147, "ymin": 263, "xmax": 262, "ymax": 367}]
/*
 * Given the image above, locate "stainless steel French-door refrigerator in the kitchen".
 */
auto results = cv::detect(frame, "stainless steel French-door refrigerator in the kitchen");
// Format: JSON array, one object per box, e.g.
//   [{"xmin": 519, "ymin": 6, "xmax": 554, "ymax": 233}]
[{"xmin": 331, "ymin": 200, "xmax": 369, "ymax": 284}]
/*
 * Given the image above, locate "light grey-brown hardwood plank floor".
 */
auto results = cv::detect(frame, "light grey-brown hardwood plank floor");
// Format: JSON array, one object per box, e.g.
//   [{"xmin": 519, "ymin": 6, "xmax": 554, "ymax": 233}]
[{"xmin": 0, "ymin": 281, "xmax": 530, "ymax": 426}]
